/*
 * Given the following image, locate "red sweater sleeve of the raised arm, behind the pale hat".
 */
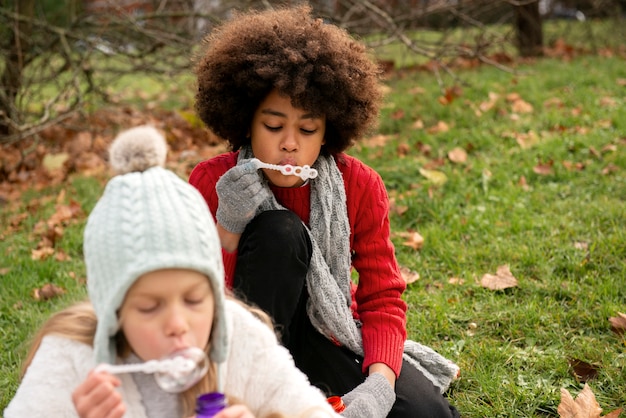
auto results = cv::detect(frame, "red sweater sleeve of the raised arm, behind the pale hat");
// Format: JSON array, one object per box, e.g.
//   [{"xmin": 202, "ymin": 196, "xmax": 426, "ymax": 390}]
[{"xmin": 189, "ymin": 152, "xmax": 238, "ymax": 288}]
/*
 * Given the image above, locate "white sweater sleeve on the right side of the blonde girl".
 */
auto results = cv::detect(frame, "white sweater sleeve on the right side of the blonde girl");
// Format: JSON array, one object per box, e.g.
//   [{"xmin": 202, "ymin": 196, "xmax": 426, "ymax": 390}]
[{"xmin": 225, "ymin": 301, "xmax": 338, "ymax": 417}]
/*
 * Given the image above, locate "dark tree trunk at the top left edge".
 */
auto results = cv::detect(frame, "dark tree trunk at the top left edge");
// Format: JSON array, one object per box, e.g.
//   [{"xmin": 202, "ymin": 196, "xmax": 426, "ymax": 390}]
[{"xmin": 0, "ymin": 0, "xmax": 35, "ymax": 142}]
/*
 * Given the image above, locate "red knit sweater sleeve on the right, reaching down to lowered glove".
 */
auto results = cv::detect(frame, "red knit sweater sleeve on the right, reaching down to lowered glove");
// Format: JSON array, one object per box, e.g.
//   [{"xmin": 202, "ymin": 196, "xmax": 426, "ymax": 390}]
[{"xmin": 339, "ymin": 156, "xmax": 406, "ymax": 376}]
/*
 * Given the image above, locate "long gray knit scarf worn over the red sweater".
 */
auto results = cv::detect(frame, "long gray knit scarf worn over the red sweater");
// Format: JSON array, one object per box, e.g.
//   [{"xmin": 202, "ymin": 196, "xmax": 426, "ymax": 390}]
[{"xmin": 238, "ymin": 147, "xmax": 459, "ymax": 393}]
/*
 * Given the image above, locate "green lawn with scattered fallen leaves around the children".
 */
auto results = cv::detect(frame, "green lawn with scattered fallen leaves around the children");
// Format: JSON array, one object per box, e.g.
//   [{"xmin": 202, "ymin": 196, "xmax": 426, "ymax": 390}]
[{"xmin": 0, "ymin": 30, "xmax": 626, "ymax": 418}]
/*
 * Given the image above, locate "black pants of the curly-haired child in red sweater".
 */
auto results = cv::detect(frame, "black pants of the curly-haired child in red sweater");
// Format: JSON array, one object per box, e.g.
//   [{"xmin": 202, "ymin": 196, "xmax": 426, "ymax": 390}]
[{"xmin": 233, "ymin": 210, "xmax": 459, "ymax": 418}]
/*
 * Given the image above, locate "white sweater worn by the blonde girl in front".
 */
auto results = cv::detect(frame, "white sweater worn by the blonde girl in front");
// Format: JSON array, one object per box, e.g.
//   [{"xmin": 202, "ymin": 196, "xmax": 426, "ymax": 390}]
[{"xmin": 4, "ymin": 301, "xmax": 337, "ymax": 418}]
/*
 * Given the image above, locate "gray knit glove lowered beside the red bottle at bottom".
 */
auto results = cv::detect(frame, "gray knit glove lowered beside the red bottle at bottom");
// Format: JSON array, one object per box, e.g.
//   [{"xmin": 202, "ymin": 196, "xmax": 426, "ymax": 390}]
[{"xmin": 341, "ymin": 373, "xmax": 396, "ymax": 418}]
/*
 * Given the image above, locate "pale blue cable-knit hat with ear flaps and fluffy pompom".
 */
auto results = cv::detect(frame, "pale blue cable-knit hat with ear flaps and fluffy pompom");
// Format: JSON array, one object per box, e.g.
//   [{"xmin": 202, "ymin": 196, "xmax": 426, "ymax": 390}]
[{"xmin": 83, "ymin": 126, "xmax": 227, "ymax": 363}]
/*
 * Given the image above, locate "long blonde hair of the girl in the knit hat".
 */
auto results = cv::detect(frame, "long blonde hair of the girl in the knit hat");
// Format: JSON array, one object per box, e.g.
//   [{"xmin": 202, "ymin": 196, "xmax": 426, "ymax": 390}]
[{"xmin": 21, "ymin": 294, "xmax": 278, "ymax": 418}]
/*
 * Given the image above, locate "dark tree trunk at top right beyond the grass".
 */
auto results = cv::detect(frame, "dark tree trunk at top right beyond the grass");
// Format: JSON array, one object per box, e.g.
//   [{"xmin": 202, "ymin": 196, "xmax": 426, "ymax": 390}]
[{"xmin": 515, "ymin": 1, "xmax": 543, "ymax": 57}]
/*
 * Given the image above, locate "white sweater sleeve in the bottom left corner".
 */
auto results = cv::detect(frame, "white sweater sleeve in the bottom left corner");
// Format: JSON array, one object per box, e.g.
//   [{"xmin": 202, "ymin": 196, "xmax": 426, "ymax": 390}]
[{"xmin": 4, "ymin": 336, "xmax": 94, "ymax": 418}]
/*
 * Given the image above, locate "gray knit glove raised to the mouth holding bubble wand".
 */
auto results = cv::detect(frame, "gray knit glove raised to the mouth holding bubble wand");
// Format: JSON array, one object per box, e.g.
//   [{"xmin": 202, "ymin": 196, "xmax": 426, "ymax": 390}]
[{"xmin": 215, "ymin": 160, "xmax": 270, "ymax": 234}]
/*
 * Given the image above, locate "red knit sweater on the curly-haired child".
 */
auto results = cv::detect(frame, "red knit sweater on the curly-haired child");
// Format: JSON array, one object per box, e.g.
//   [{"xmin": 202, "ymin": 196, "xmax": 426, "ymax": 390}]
[{"xmin": 189, "ymin": 152, "xmax": 406, "ymax": 377}]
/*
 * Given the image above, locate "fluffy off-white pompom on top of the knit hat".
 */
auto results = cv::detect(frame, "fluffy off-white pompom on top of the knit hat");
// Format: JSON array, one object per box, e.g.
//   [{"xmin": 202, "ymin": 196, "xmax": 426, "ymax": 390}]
[{"xmin": 109, "ymin": 125, "xmax": 167, "ymax": 174}]
